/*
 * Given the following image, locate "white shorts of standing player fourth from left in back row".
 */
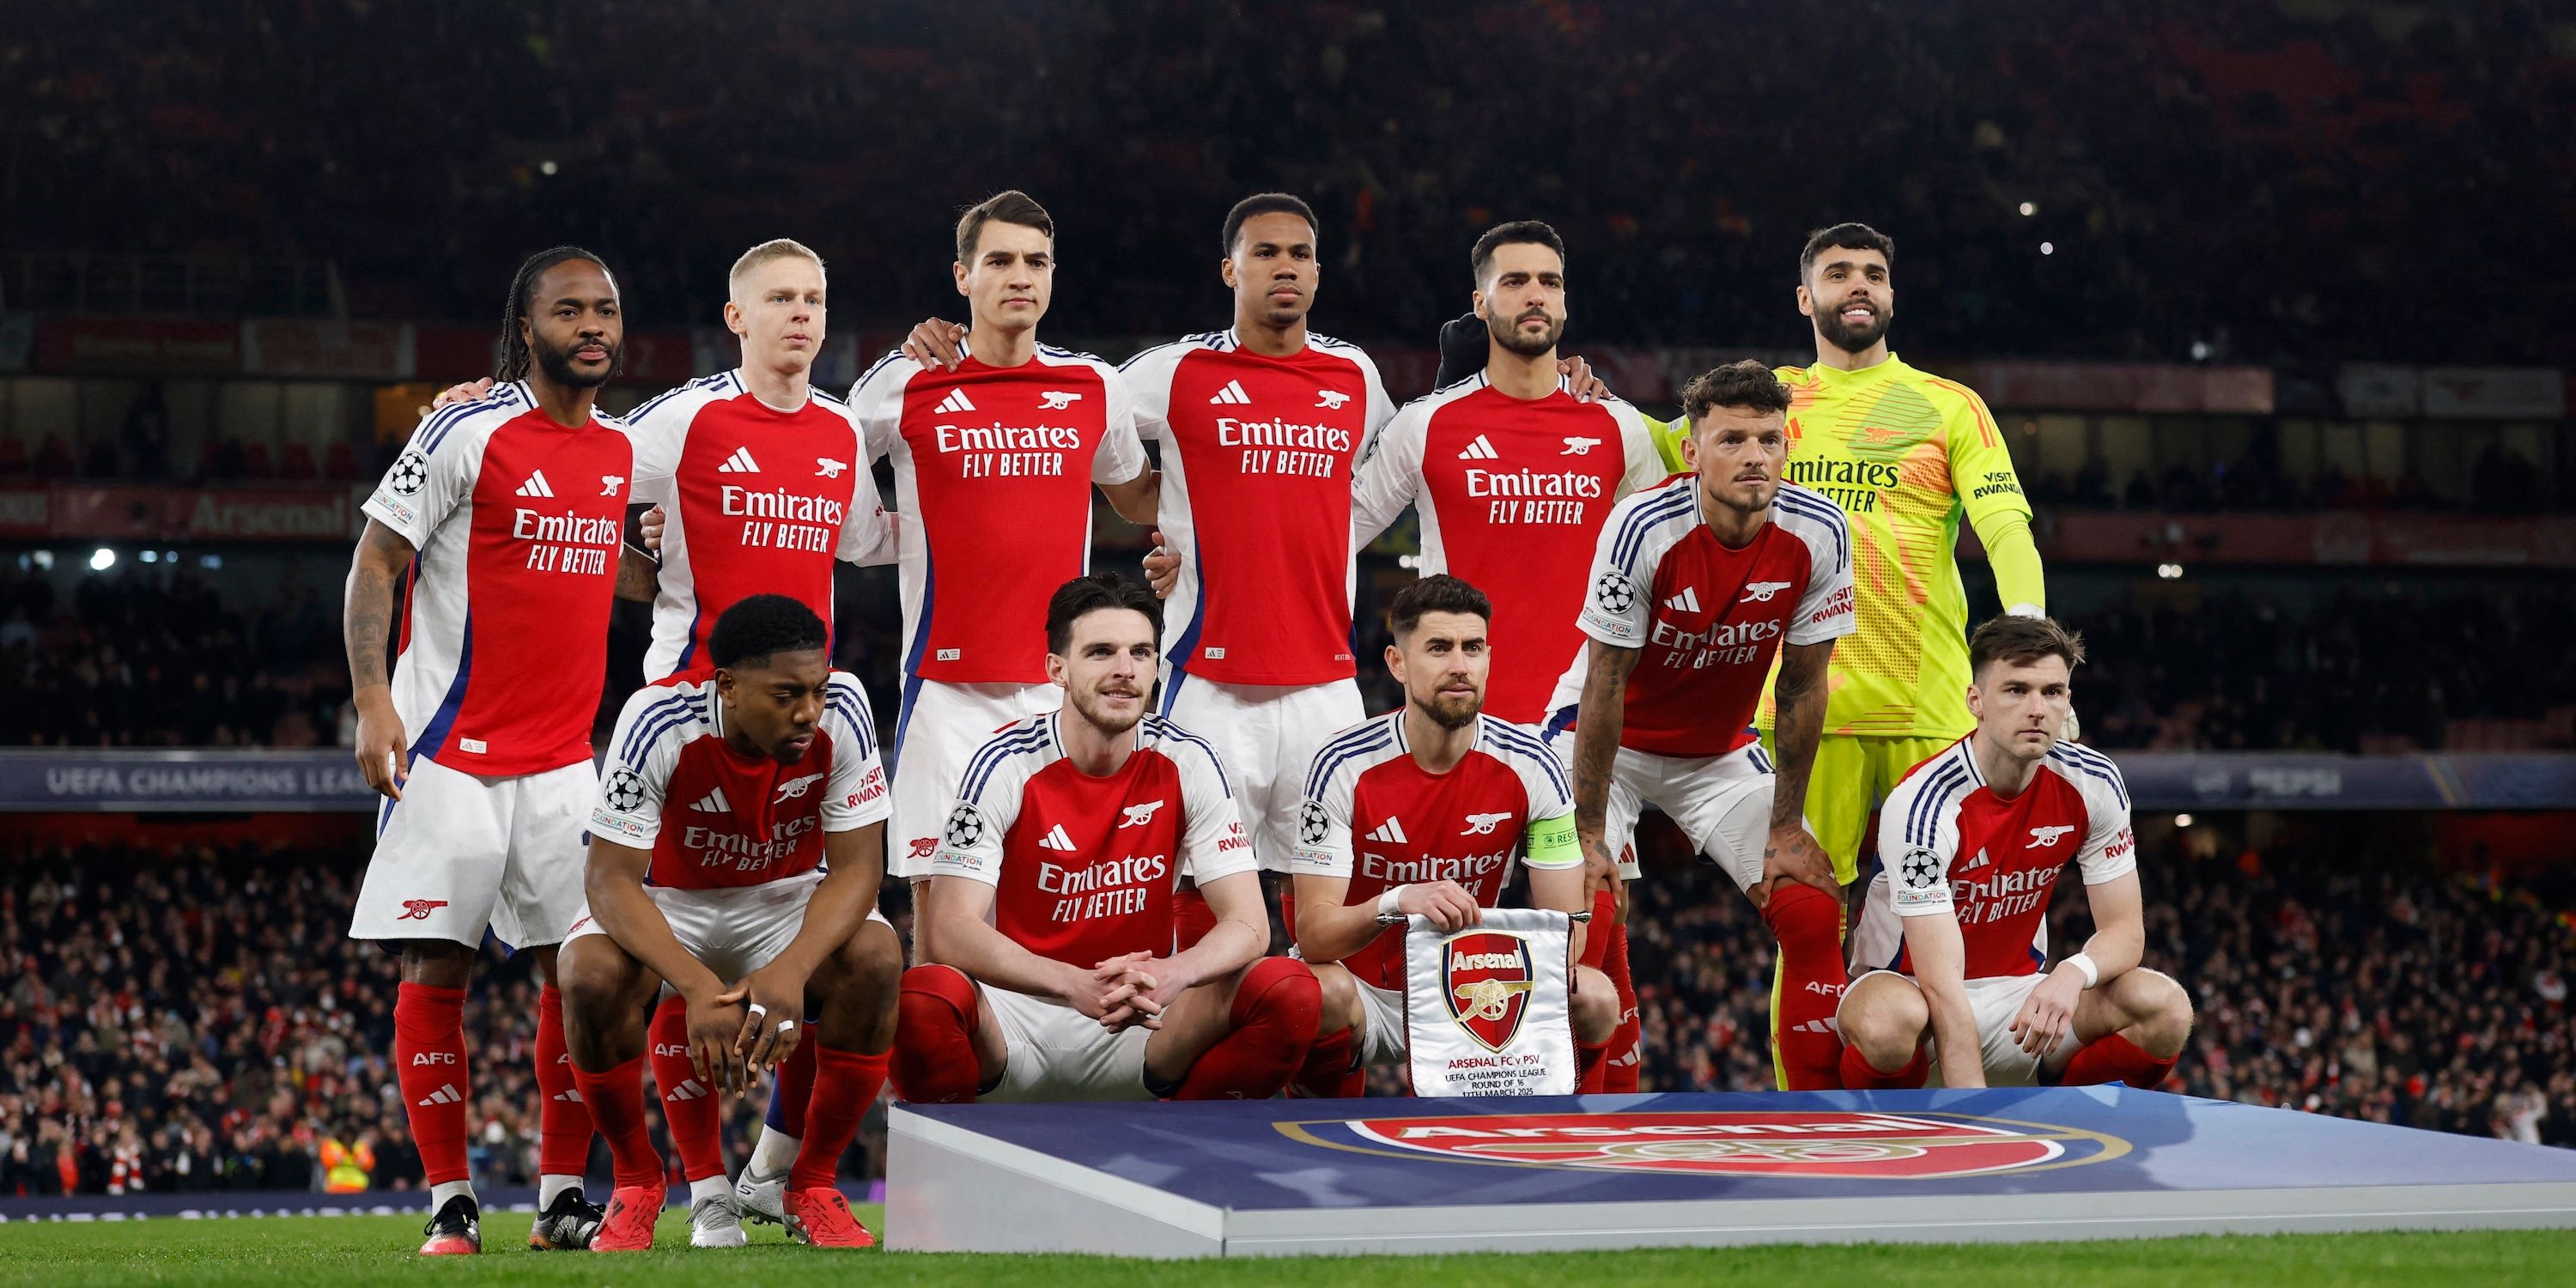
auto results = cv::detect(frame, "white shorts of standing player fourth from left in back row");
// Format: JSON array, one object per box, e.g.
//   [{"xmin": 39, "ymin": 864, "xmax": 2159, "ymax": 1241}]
[{"xmin": 1162, "ymin": 667, "xmax": 1368, "ymax": 873}]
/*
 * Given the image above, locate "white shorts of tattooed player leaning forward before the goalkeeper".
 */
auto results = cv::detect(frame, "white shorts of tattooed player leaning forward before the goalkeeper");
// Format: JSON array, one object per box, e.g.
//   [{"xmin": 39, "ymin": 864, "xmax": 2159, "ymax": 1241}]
[{"xmin": 1548, "ymin": 729, "xmax": 1772, "ymax": 889}]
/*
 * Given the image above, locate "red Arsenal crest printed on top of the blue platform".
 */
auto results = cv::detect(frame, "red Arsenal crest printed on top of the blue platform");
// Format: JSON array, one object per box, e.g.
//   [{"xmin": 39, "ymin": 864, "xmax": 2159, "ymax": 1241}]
[{"xmin": 1329, "ymin": 1110, "xmax": 2128, "ymax": 1177}]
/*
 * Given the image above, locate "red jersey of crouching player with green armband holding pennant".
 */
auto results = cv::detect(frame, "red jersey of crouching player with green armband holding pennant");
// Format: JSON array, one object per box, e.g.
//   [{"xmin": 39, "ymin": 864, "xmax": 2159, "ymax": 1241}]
[{"xmin": 1288, "ymin": 708, "xmax": 1584, "ymax": 992}]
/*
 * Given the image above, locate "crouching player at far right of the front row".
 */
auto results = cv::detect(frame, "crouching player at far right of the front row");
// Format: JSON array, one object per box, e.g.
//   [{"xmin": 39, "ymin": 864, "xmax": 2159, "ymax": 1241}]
[{"xmin": 1842, "ymin": 616, "xmax": 2192, "ymax": 1090}]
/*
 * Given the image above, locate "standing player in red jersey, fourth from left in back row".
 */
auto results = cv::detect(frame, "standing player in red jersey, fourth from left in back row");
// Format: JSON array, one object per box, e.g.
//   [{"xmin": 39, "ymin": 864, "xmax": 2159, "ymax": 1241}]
[{"xmin": 912, "ymin": 193, "xmax": 1394, "ymax": 886}]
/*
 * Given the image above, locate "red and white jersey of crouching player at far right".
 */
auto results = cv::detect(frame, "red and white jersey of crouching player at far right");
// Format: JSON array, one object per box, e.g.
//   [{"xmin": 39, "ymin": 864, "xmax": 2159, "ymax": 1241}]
[{"xmin": 1852, "ymin": 734, "xmax": 2138, "ymax": 979}]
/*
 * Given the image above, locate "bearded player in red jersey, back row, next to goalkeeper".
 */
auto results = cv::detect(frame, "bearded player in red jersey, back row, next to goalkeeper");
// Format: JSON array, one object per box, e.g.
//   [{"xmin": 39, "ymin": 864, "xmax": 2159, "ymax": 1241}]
[{"xmin": 1352, "ymin": 219, "xmax": 1664, "ymax": 724}]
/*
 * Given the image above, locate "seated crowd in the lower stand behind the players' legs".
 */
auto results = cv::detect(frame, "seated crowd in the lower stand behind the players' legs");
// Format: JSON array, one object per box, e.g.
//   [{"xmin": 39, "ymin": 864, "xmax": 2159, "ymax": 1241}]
[{"xmin": 0, "ymin": 837, "xmax": 2576, "ymax": 1195}]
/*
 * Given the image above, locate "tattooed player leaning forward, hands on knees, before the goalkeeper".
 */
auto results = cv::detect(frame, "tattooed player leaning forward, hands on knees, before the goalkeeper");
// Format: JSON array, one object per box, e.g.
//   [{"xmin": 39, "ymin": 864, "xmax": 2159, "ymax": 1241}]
[{"xmin": 1548, "ymin": 361, "xmax": 1852, "ymax": 1090}]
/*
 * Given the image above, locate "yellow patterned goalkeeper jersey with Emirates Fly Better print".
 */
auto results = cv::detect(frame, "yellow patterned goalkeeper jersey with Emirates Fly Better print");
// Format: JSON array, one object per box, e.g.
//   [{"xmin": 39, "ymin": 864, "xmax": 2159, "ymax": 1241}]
[{"xmin": 1759, "ymin": 353, "xmax": 2038, "ymax": 737}]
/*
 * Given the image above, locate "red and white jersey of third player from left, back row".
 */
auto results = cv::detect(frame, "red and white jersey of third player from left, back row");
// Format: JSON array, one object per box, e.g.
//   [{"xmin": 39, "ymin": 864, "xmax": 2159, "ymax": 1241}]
[{"xmin": 850, "ymin": 345, "xmax": 1146, "ymax": 685}]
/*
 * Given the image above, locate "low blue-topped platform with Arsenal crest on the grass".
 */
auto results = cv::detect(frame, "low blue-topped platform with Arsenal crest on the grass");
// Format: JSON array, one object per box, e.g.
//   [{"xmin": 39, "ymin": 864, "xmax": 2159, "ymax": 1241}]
[{"xmin": 886, "ymin": 1087, "xmax": 2576, "ymax": 1257}]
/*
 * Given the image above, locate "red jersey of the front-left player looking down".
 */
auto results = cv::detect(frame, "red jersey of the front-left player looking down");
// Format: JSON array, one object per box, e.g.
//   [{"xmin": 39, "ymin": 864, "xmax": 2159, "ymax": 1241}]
[{"xmin": 590, "ymin": 670, "xmax": 891, "ymax": 889}]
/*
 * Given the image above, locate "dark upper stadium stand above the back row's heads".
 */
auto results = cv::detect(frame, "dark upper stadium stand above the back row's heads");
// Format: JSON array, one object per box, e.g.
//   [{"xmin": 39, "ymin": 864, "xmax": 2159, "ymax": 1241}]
[{"xmin": 0, "ymin": 0, "xmax": 2576, "ymax": 361}]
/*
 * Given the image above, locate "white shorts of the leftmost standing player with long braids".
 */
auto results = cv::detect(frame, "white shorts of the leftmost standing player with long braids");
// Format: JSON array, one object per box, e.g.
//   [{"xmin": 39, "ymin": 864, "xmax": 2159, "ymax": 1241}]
[{"xmin": 348, "ymin": 757, "xmax": 600, "ymax": 948}]
